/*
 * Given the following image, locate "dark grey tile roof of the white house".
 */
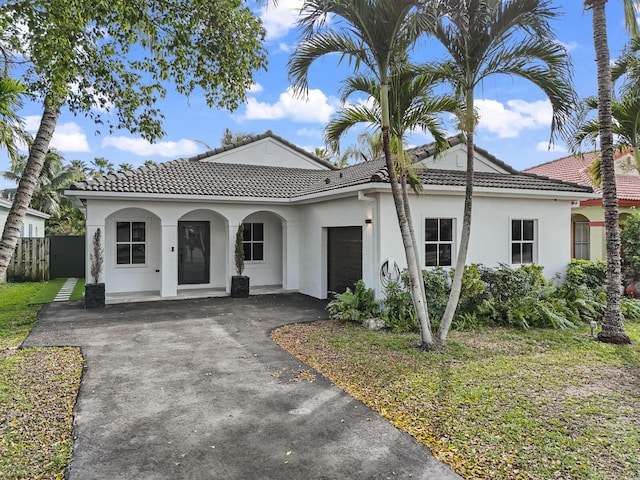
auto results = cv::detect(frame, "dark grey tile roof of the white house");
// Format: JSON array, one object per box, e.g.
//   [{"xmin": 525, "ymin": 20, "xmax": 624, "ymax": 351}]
[{"xmin": 71, "ymin": 136, "xmax": 591, "ymax": 198}]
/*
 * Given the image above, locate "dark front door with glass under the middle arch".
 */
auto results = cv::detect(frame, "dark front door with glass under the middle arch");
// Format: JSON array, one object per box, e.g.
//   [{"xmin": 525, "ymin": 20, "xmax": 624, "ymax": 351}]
[{"xmin": 178, "ymin": 222, "xmax": 211, "ymax": 285}]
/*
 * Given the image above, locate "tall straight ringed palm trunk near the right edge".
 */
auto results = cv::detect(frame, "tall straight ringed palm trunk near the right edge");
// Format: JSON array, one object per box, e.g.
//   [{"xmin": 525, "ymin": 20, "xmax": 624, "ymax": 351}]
[{"xmin": 591, "ymin": 0, "xmax": 631, "ymax": 344}]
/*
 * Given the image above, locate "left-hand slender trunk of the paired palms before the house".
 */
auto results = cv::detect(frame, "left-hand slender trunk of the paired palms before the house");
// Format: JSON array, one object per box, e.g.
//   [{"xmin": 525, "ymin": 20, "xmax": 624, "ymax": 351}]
[{"xmin": 380, "ymin": 82, "xmax": 435, "ymax": 350}]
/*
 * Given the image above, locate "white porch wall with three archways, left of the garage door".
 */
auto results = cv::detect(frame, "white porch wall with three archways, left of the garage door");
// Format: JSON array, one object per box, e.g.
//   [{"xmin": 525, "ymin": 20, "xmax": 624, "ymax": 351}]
[{"xmin": 86, "ymin": 198, "xmax": 299, "ymax": 297}]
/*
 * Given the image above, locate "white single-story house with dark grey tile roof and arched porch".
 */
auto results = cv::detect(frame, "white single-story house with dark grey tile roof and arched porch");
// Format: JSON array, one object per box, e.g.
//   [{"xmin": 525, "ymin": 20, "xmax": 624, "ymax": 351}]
[{"xmin": 66, "ymin": 132, "xmax": 593, "ymax": 298}]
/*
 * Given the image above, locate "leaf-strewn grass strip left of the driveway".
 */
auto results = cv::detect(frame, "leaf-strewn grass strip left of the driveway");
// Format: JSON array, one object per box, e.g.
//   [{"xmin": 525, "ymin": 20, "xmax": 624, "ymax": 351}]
[{"xmin": 0, "ymin": 283, "xmax": 82, "ymax": 479}]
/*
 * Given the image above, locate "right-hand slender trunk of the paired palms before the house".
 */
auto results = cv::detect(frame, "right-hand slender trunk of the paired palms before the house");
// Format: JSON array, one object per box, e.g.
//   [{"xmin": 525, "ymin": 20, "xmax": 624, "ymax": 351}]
[{"xmin": 436, "ymin": 95, "xmax": 475, "ymax": 344}]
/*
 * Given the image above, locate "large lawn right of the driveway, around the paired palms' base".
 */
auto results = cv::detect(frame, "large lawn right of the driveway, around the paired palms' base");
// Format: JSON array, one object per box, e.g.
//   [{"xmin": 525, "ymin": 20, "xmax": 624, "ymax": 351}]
[{"xmin": 272, "ymin": 321, "xmax": 640, "ymax": 479}]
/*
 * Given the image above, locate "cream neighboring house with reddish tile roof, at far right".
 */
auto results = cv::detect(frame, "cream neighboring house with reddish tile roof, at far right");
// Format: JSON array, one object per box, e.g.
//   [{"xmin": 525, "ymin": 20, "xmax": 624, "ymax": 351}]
[{"xmin": 525, "ymin": 151, "xmax": 640, "ymax": 260}]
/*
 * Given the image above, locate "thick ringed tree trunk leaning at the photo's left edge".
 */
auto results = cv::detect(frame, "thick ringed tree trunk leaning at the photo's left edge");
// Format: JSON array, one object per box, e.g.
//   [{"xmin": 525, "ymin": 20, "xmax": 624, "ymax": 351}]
[{"xmin": 0, "ymin": 99, "xmax": 60, "ymax": 278}]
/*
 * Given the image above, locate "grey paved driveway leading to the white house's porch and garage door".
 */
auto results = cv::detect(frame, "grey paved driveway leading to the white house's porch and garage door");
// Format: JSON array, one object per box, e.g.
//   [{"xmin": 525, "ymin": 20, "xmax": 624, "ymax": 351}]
[{"xmin": 24, "ymin": 294, "xmax": 460, "ymax": 480}]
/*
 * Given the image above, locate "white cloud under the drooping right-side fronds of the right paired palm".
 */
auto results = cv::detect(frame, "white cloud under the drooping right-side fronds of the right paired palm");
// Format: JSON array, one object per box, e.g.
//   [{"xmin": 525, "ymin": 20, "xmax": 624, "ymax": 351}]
[{"xmin": 476, "ymin": 100, "xmax": 553, "ymax": 138}]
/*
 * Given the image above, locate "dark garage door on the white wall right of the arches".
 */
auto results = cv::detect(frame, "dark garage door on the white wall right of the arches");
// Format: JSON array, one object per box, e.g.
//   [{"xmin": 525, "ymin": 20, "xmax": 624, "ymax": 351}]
[{"xmin": 327, "ymin": 227, "xmax": 362, "ymax": 293}]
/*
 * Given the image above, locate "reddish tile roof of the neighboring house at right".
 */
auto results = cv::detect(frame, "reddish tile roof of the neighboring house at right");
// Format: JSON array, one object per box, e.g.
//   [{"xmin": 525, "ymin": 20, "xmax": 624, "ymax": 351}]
[{"xmin": 525, "ymin": 152, "xmax": 640, "ymax": 201}]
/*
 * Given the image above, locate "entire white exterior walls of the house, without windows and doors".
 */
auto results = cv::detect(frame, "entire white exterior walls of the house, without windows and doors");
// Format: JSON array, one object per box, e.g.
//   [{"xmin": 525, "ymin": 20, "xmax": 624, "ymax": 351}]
[{"xmin": 81, "ymin": 188, "xmax": 571, "ymax": 298}]
